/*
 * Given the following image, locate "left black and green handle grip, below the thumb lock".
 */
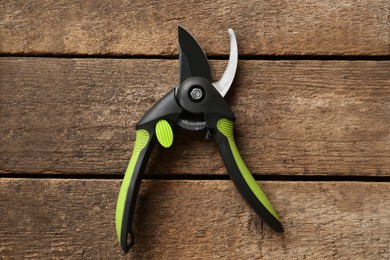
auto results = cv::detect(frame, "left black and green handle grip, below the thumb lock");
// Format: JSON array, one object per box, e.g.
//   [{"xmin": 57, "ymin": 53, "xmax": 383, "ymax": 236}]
[{"xmin": 115, "ymin": 129, "xmax": 155, "ymax": 253}]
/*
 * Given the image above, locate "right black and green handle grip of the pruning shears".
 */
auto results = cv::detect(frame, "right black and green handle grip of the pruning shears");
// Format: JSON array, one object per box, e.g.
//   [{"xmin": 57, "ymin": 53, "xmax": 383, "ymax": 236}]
[{"xmin": 214, "ymin": 119, "xmax": 284, "ymax": 232}]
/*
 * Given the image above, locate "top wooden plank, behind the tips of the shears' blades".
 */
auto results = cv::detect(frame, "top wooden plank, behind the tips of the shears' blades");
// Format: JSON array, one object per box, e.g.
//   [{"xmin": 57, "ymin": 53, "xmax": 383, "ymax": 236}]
[{"xmin": 0, "ymin": 0, "xmax": 390, "ymax": 56}]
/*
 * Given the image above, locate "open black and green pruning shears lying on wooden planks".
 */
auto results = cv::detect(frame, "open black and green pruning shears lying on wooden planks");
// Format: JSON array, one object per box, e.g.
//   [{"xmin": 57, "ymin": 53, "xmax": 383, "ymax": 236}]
[{"xmin": 115, "ymin": 26, "xmax": 283, "ymax": 252}]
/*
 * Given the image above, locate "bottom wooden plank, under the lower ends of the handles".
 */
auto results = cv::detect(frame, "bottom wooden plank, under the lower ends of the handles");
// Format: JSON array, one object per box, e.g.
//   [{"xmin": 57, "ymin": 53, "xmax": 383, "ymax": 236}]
[{"xmin": 0, "ymin": 178, "xmax": 390, "ymax": 259}]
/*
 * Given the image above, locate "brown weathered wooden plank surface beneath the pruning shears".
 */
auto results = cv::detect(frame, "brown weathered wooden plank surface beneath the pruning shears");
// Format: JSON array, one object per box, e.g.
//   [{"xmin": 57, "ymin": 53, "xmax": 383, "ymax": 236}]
[{"xmin": 0, "ymin": 0, "xmax": 390, "ymax": 259}]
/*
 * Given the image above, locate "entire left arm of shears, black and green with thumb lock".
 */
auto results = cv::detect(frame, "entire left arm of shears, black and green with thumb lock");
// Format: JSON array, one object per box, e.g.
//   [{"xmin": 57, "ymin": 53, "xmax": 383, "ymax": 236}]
[{"xmin": 115, "ymin": 89, "xmax": 183, "ymax": 253}]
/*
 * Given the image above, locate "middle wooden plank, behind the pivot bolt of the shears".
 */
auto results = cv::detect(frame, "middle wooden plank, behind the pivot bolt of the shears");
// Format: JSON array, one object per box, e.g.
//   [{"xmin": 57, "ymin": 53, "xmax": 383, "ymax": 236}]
[{"xmin": 0, "ymin": 58, "xmax": 390, "ymax": 176}]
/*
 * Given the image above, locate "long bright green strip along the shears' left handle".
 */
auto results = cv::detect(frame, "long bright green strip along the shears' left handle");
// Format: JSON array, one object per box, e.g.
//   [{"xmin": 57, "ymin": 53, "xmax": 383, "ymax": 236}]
[{"xmin": 115, "ymin": 129, "xmax": 149, "ymax": 242}]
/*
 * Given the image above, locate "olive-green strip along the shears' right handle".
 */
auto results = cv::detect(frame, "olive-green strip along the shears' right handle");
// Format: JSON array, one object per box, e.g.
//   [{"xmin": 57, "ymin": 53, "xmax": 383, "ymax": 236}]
[{"xmin": 217, "ymin": 119, "xmax": 280, "ymax": 221}]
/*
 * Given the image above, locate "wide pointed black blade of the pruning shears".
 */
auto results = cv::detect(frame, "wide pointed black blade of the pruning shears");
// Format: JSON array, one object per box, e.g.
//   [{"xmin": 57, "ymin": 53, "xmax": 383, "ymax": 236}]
[{"xmin": 178, "ymin": 26, "xmax": 211, "ymax": 83}]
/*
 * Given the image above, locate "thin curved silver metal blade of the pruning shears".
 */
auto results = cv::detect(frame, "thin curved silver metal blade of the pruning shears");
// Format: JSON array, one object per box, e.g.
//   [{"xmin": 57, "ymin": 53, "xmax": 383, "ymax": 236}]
[{"xmin": 213, "ymin": 28, "xmax": 238, "ymax": 97}]
